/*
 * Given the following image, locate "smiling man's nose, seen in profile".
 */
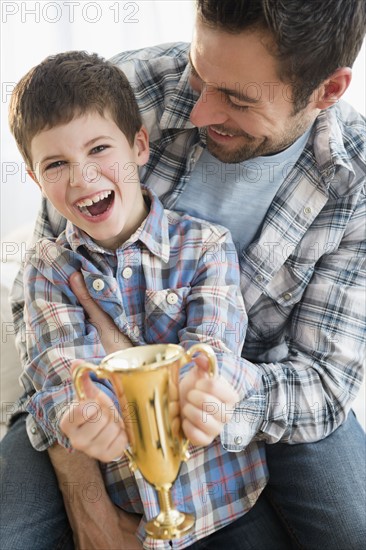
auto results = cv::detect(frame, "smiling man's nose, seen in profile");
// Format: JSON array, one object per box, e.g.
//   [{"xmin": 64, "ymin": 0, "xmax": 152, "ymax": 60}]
[{"xmin": 190, "ymin": 83, "xmax": 229, "ymax": 128}]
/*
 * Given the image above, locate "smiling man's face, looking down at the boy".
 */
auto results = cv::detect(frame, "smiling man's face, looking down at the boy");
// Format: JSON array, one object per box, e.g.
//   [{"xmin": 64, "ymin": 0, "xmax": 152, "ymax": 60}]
[{"xmin": 190, "ymin": 19, "xmax": 319, "ymax": 163}]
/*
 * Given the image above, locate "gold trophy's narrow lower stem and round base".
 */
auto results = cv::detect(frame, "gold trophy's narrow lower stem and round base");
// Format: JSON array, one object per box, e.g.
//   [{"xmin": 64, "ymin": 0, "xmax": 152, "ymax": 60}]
[{"xmin": 145, "ymin": 484, "xmax": 194, "ymax": 540}]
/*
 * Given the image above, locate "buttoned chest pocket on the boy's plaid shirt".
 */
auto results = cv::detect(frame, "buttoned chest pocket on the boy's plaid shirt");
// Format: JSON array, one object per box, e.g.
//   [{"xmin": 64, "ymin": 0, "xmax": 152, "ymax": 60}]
[{"xmin": 144, "ymin": 287, "xmax": 190, "ymax": 343}]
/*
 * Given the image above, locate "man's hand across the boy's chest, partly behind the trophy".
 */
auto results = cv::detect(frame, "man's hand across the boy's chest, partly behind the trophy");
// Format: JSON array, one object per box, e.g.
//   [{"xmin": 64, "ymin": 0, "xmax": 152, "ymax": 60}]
[{"xmin": 69, "ymin": 271, "xmax": 132, "ymax": 354}]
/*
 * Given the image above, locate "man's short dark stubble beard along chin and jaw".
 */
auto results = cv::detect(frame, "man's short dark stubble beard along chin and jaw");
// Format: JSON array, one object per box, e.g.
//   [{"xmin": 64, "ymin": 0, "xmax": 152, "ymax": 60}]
[{"xmin": 207, "ymin": 112, "xmax": 312, "ymax": 164}]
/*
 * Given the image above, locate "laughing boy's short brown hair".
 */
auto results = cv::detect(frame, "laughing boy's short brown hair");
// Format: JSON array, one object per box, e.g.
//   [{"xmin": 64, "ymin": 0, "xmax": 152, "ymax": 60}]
[{"xmin": 9, "ymin": 51, "xmax": 142, "ymax": 169}]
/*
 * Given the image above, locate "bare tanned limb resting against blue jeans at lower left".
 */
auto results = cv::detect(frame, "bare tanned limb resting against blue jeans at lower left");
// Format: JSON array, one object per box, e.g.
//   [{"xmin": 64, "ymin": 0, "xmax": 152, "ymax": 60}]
[{"xmin": 48, "ymin": 445, "xmax": 142, "ymax": 550}]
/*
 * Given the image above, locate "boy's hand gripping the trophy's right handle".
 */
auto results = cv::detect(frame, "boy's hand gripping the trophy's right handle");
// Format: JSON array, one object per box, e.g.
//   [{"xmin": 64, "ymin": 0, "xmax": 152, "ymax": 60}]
[{"xmin": 179, "ymin": 354, "xmax": 239, "ymax": 447}]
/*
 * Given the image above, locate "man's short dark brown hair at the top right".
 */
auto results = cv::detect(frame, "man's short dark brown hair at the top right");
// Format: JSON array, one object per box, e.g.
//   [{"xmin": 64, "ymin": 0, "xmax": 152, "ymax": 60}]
[{"xmin": 197, "ymin": 0, "xmax": 366, "ymax": 111}]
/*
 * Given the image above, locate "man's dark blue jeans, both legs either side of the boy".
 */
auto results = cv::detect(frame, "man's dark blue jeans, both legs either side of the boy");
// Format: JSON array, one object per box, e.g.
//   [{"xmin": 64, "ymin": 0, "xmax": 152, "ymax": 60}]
[{"xmin": 0, "ymin": 413, "xmax": 366, "ymax": 550}]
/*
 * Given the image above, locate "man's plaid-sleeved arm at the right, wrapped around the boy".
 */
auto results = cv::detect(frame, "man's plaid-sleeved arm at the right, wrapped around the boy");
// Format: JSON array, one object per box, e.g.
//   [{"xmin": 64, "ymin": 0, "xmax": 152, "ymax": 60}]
[{"xmin": 225, "ymin": 194, "xmax": 366, "ymax": 450}]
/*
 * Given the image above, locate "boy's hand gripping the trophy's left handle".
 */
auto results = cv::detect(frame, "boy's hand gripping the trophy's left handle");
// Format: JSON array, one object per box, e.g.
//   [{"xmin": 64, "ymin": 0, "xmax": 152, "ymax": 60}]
[{"xmin": 60, "ymin": 361, "xmax": 128, "ymax": 462}]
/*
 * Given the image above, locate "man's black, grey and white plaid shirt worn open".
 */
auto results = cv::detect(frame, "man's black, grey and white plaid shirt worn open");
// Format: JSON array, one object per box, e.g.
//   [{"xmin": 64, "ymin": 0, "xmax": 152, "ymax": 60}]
[{"xmin": 13, "ymin": 44, "xmax": 366, "ymax": 548}]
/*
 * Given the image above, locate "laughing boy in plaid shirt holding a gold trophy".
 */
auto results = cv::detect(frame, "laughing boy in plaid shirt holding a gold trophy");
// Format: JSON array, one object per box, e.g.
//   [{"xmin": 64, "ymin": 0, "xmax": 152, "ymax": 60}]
[{"xmin": 10, "ymin": 52, "xmax": 260, "ymax": 548}]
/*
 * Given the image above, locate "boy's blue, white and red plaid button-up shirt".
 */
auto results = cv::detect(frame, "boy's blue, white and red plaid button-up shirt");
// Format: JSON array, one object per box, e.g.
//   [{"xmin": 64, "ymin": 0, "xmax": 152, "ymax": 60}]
[{"xmin": 22, "ymin": 190, "xmax": 267, "ymax": 548}]
